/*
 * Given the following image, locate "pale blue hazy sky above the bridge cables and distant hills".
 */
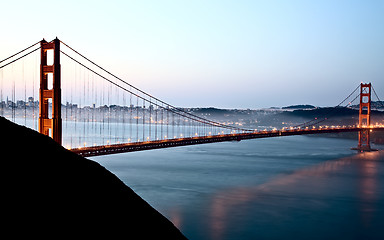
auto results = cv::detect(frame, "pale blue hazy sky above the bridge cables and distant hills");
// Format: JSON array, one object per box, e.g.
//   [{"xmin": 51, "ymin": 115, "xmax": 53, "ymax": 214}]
[{"xmin": 0, "ymin": 0, "xmax": 384, "ymax": 108}]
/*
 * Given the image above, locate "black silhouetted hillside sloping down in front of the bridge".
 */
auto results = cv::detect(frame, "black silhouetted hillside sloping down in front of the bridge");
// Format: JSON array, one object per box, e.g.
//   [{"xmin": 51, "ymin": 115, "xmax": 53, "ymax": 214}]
[{"xmin": 0, "ymin": 117, "xmax": 185, "ymax": 239}]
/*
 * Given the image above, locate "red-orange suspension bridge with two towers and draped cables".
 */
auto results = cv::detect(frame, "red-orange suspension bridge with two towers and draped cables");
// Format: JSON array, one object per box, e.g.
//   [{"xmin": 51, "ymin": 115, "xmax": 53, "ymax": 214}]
[{"xmin": 0, "ymin": 38, "xmax": 384, "ymax": 156}]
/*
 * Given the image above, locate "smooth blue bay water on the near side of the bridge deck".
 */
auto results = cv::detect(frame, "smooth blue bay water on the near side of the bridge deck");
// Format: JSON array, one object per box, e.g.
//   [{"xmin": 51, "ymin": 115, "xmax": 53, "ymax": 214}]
[{"xmin": 91, "ymin": 136, "xmax": 384, "ymax": 239}]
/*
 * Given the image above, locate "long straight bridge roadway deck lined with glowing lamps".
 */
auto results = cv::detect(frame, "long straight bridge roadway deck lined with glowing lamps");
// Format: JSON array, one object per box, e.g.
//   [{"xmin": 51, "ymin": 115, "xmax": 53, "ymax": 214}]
[{"xmin": 71, "ymin": 126, "xmax": 384, "ymax": 157}]
